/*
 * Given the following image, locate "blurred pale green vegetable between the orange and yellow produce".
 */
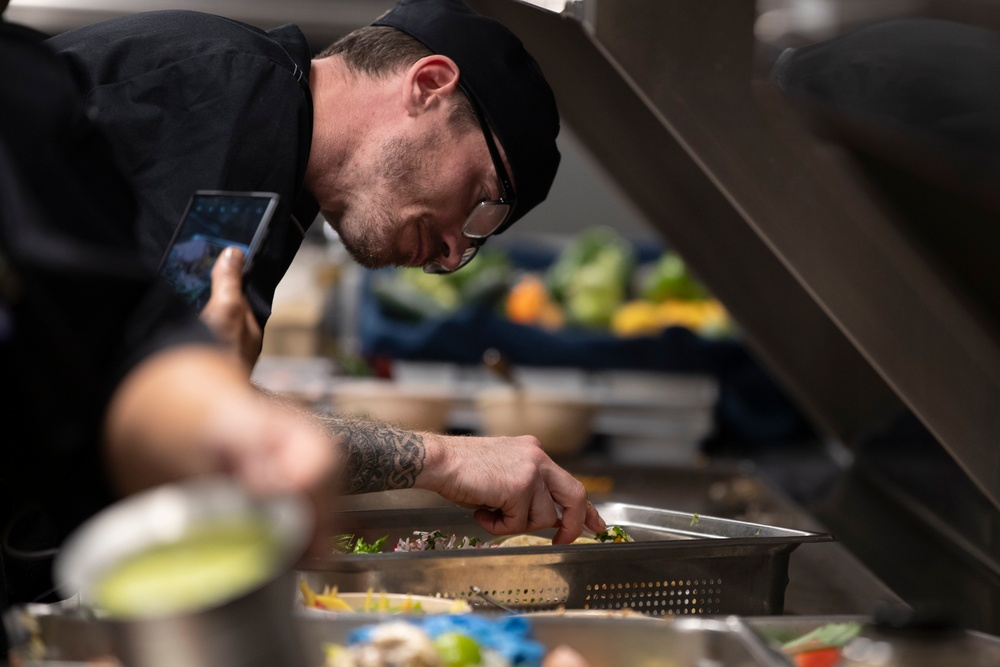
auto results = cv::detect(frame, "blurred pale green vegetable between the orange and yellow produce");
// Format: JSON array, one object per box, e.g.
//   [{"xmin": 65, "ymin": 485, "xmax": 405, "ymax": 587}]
[{"xmin": 545, "ymin": 227, "xmax": 634, "ymax": 328}]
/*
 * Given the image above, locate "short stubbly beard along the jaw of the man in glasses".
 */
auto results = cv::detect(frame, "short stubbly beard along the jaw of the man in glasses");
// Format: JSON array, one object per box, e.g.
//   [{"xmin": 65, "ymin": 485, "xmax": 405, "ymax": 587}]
[{"xmin": 337, "ymin": 132, "xmax": 425, "ymax": 269}]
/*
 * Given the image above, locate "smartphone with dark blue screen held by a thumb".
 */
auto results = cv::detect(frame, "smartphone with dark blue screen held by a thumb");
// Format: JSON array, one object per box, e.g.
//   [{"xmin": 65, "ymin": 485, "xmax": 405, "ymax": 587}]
[{"xmin": 159, "ymin": 191, "xmax": 278, "ymax": 312}]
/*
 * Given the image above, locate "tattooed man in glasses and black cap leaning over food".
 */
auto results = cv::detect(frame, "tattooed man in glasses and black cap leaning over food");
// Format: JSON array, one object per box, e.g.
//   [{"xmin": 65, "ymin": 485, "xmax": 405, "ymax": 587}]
[{"xmin": 48, "ymin": 0, "xmax": 603, "ymax": 542}]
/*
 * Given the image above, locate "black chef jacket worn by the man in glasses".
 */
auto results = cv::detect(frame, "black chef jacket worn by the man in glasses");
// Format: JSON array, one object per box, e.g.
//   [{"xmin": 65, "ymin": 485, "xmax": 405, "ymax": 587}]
[{"xmin": 48, "ymin": 11, "xmax": 319, "ymax": 326}]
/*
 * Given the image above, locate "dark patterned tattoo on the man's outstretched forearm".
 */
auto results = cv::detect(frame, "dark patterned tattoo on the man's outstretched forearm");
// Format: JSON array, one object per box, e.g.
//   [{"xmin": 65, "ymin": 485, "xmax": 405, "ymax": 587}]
[{"xmin": 323, "ymin": 416, "xmax": 427, "ymax": 494}]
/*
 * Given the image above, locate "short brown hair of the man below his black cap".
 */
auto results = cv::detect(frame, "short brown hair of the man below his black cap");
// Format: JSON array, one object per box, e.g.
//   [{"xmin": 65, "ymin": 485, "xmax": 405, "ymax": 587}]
[{"xmin": 316, "ymin": 26, "xmax": 478, "ymax": 127}]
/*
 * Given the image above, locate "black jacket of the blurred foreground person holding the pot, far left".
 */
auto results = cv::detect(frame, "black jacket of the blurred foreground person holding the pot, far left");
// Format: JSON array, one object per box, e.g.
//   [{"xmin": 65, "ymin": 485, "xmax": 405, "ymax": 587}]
[{"xmin": 0, "ymin": 20, "xmax": 212, "ymax": 640}]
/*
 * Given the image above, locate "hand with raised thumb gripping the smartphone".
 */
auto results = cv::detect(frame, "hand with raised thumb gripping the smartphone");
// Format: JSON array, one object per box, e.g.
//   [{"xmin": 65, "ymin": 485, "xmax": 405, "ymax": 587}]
[{"xmin": 201, "ymin": 248, "xmax": 264, "ymax": 376}]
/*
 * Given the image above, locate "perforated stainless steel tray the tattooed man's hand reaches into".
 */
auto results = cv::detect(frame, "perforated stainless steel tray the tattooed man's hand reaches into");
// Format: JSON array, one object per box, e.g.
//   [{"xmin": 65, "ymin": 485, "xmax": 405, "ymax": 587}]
[{"xmin": 298, "ymin": 503, "xmax": 833, "ymax": 617}]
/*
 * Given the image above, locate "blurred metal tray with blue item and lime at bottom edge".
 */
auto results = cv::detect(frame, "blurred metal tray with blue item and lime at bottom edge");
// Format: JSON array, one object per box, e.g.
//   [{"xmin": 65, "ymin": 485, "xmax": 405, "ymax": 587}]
[{"xmin": 292, "ymin": 615, "xmax": 788, "ymax": 667}]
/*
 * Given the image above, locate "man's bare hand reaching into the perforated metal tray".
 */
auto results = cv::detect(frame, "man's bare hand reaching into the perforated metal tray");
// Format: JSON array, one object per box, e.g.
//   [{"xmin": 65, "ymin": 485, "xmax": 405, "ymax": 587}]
[{"xmin": 414, "ymin": 433, "xmax": 607, "ymax": 544}]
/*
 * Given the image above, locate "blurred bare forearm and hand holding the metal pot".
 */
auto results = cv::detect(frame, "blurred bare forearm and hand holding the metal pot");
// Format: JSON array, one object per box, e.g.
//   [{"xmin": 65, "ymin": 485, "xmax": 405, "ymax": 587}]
[{"xmin": 104, "ymin": 345, "xmax": 342, "ymax": 554}]
